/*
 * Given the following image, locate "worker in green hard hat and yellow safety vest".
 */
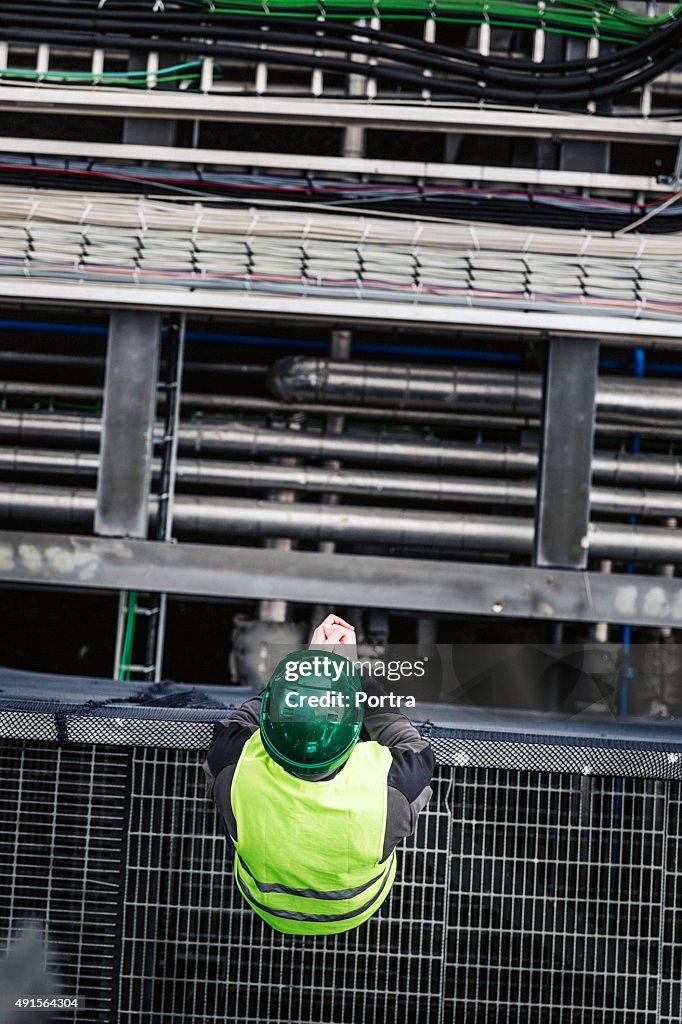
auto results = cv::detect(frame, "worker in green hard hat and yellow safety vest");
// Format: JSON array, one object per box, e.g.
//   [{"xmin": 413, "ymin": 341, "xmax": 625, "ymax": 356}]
[{"xmin": 204, "ymin": 614, "xmax": 434, "ymax": 935}]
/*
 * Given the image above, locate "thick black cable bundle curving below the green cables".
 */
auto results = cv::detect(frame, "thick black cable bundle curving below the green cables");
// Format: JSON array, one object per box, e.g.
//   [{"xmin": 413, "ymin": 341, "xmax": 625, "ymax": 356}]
[{"xmin": 0, "ymin": 3, "xmax": 682, "ymax": 106}]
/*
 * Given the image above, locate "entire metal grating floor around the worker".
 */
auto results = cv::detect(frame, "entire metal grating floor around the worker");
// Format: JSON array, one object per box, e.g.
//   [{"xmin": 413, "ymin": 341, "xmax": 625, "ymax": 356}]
[{"xmin": 0, "ymin": 740, "xmax": 682, "ymax": 1024}]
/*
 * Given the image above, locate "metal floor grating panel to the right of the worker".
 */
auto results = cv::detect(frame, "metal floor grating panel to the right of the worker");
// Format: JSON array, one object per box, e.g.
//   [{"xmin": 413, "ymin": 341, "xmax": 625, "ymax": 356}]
[{"xmin": 449, "ymin": 770, "xmax": 680, "ymax": 1024}]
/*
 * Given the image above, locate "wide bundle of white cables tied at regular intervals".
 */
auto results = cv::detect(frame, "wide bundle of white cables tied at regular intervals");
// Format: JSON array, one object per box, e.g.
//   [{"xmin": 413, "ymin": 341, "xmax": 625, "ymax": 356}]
[{"xmin": 0, "ymin": 188, "xmax": 682, "ymax": 319}]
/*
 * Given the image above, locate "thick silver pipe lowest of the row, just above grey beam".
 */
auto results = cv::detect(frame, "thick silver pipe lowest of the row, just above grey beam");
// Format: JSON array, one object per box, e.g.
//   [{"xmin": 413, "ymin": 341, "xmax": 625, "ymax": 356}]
[{"xmin": 0, "ymin": 484, "xmax": 682, "ymax": 564}]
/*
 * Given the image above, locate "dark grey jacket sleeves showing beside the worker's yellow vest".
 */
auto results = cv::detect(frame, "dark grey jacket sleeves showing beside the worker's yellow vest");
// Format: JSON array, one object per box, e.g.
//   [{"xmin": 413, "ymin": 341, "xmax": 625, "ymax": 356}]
[{"xmin": 204, "ymin": 680, "xmax": 434, "ymax": 858}]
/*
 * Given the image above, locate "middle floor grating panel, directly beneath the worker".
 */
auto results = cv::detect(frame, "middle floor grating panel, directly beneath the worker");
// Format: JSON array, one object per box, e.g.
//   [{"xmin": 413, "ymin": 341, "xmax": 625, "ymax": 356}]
[{"xmin": 119, "ymin": 751, "xmax": 450, "ymax": 1024}]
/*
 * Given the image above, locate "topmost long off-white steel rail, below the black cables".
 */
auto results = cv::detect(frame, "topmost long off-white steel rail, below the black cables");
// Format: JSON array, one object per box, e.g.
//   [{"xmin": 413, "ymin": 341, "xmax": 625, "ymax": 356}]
[{"xmin": 0, "ymin": 85, "xmax": 682, "ymax": 143}]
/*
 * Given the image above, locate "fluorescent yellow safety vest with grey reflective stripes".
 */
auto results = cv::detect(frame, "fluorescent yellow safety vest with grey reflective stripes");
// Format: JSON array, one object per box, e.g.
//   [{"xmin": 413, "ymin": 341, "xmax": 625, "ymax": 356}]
[{"xmin": 231, "ymin": 731, "xmax": 395, "ymax": 934}]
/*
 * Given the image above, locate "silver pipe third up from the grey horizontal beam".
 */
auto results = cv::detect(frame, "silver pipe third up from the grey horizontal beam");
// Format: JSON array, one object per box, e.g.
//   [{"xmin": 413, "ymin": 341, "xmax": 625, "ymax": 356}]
[{"xmin": 0, "ymin": 412, "xmax": 682, "ymax": 487}]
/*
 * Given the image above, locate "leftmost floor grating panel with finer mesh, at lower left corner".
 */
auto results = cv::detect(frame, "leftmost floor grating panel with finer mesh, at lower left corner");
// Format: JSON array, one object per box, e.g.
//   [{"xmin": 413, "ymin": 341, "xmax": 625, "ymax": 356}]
[{"xmin": 0, "ymin": 741, "xmax": 130, "ymax": 1020}]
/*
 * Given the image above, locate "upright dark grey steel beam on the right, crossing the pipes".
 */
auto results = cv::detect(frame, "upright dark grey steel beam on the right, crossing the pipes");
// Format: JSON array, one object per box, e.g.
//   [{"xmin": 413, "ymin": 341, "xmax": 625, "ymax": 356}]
[{"xmin": 534, "ymin": 337, "xmax": 599, "ymax": 569}]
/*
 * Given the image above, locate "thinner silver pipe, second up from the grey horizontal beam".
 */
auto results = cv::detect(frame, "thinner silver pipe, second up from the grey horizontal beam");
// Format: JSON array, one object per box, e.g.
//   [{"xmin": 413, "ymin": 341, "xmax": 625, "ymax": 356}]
[{"xmin": 0, "ymin": 447, "xmax": 680, "ymax": 516}]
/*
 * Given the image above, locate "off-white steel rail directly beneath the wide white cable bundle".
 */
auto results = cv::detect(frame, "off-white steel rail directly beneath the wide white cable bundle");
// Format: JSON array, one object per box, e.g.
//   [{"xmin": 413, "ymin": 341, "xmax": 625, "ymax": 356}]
[{"xmin": 0, "ymin": 276, "xmax": 682, "ymax": 346}]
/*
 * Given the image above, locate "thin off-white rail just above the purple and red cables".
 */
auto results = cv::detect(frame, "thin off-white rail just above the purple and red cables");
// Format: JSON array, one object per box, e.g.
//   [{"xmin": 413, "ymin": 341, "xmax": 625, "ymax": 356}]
[{"xmin": 2, "ymin": 137, "xmax": 670, "ymax": 194}]
